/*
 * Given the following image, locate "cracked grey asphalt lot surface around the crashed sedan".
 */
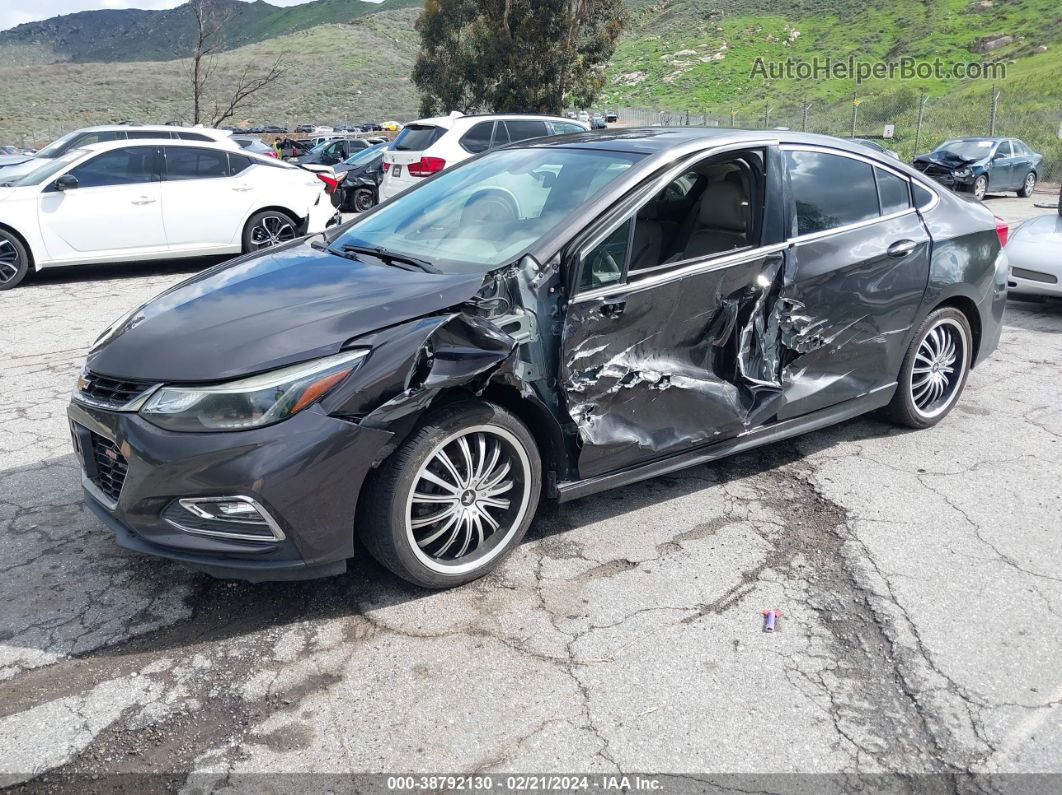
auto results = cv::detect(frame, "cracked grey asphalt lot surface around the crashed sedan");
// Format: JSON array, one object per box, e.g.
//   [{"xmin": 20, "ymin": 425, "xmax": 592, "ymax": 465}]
[{"xmin": 0, "ymin": 195, "xmax": 1062, "ymax": 791}]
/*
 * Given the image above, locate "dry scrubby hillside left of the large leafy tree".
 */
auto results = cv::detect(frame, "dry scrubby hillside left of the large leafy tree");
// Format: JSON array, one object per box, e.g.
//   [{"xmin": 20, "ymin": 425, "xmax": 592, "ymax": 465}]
[{"xmin": 0, "ymin": 8, "xmax": 417, "ymax": 143}]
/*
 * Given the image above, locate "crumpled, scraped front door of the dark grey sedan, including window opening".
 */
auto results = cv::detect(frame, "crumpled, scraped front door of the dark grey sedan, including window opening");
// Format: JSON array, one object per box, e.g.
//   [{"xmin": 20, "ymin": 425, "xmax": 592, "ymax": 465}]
[{"xmin": 560, "ymin": 150, "xmax": 785, "ymax": 478}]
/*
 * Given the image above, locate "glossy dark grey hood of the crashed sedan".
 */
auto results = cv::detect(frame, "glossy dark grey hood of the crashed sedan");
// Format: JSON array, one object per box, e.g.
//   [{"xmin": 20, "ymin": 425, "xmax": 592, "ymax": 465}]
[{"xmin": 87, "ymin": 237, "xmax": 483, "ymax": 382}]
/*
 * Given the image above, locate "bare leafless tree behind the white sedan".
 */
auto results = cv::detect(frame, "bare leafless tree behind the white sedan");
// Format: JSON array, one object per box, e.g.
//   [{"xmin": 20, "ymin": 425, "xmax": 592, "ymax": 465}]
[{"xmin": 188, "ymin": 0, "xmax": 285, "ymax": 127}]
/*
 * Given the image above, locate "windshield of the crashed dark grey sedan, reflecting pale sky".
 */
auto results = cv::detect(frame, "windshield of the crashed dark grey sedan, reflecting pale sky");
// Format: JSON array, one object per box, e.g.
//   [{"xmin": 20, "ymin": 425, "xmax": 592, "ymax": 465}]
[{"xmin": 330, "ymin": 148, "xmax": 641, "ymax": 273}]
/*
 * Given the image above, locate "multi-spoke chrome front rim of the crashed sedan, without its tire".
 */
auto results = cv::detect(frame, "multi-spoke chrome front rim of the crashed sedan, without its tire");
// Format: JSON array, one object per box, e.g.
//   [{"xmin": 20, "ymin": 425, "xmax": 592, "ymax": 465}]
[{"xmin": 406, "ymin": 425, "xmax": 531, "ymax": 574}]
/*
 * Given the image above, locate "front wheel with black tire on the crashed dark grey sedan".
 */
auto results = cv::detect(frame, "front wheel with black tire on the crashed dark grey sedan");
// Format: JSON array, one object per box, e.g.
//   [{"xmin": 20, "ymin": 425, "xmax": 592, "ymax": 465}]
[{"xmin": 358, "ymin": 400, "xmax": 542, "ymax": 588}]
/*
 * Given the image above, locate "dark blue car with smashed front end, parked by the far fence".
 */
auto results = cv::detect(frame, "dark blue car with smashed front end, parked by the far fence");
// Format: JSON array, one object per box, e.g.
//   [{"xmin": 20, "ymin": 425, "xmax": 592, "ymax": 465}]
[{"xmin": 914, "ymin": 138, "xmax": 1044, "ymax": 200}]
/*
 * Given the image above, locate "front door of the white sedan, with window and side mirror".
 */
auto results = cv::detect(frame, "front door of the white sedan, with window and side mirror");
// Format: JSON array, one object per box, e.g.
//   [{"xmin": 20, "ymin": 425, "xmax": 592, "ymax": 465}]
[{"xmin": 38, "ymin": 146, "xmax": 166, "ymax": 260}]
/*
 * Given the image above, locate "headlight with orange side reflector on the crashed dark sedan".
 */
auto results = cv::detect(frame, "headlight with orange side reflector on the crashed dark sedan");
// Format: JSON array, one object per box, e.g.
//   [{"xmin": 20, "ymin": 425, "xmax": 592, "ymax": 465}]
[{"xmin": 140, "ymin": 348, "xmax": 369, "ymax": 431}]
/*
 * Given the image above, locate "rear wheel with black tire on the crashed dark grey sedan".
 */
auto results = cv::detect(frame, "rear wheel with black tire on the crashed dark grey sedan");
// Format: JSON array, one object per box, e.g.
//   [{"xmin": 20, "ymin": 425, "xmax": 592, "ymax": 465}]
[{"xmin": 884, "ymin": 307, "xmax": 974, "ymax": 428}]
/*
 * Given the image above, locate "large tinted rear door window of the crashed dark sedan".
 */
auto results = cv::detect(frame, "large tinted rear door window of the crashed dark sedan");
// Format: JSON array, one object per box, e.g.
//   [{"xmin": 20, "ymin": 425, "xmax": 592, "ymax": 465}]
[{"xmin": 786, "ymin": 150, "xmax": 878, "ymax": 235}]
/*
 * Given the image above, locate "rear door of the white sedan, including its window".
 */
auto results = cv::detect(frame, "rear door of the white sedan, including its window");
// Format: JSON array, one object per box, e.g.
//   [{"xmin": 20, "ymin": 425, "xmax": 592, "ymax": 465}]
[{"xmin": 162, "ymin": 146, "xmax": 252, "ymax": 252}]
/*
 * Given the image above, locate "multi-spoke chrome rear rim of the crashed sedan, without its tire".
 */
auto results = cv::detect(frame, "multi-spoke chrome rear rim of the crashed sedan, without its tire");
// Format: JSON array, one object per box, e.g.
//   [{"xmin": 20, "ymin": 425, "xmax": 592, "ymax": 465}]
[{"xmin": 910, "ymin": 317, "xmax": 970, "ymax": 419}]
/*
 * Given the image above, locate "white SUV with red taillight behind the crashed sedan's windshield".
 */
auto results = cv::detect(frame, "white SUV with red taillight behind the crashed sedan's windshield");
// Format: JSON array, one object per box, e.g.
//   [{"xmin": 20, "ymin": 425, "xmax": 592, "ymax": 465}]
[{"xmin": 380, "ymin": 113, "xmax": 589, "ymax": 202}]
